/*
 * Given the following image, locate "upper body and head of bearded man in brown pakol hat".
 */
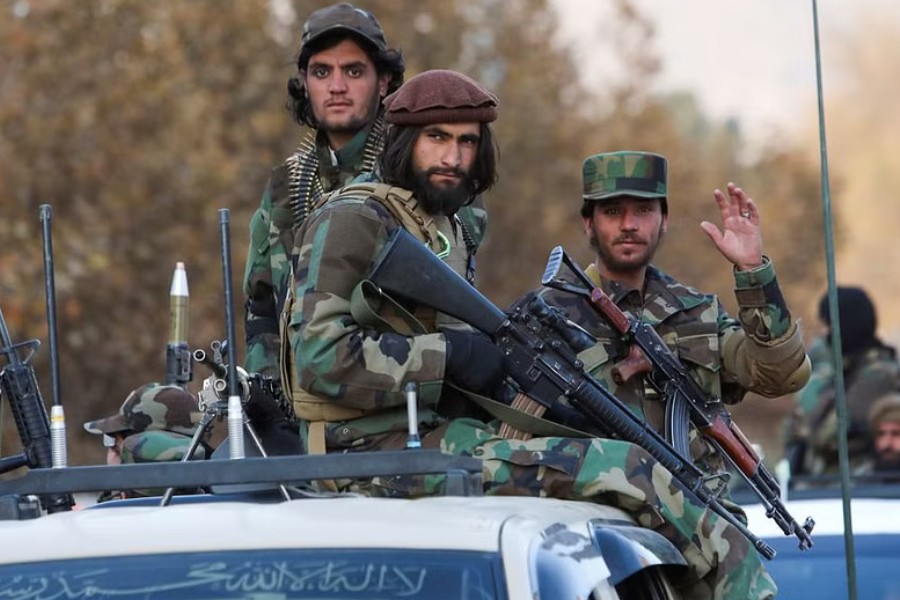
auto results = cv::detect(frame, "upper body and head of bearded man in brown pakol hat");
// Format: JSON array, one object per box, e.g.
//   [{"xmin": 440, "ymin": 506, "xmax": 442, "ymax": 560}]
[{"xmin": 282, "ymin": 70, "xmax": 502, "ymax": 451}]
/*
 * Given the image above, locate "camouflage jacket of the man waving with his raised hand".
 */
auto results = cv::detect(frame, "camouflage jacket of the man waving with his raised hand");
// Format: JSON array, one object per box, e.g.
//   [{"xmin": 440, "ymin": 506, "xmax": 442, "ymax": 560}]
[{"xmin": 539, "ymin": 259, "xmax": 808, "ymax": 471}]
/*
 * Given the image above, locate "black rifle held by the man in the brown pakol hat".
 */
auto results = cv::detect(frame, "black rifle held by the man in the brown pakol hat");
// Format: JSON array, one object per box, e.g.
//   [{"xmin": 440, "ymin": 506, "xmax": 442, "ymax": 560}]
[{"xmin": 368, "ymin": 228, "xmax": 775, "ymax": 559}]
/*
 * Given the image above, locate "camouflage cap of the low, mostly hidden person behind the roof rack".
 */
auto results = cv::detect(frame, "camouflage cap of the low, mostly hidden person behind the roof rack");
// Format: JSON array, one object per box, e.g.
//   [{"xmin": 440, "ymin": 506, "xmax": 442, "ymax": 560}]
[{"xmin": 84, "ymin": 383, "xmax": 201, "ymax": 435}]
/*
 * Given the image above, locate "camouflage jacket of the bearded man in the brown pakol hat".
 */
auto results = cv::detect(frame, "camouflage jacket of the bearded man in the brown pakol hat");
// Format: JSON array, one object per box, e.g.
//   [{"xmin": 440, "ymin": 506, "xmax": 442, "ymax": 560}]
[{"xmin": 283, "ymin": 183, "xmax": 478, "ymax": 449}]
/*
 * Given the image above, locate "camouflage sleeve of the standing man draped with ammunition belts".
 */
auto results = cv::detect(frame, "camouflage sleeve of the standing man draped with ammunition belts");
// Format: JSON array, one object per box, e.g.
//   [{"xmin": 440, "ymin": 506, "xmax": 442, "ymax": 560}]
[{"xmin": 244, "ymin": 180, "xmax": 280, "ymax": 378}]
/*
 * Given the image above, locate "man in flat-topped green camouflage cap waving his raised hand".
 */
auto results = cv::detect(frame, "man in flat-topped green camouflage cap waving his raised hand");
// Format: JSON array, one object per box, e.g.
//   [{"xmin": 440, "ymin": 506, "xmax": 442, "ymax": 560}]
[{"xmin": 540, "ymin": 151, "xmax": 810, "ymax": 480}]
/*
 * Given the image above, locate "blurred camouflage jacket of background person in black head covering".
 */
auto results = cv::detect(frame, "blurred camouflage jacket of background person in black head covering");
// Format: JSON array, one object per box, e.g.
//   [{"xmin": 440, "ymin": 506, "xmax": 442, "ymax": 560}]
[{"xmin": 789, "ymin": 338, "xmax": 900, "ymax": 475}]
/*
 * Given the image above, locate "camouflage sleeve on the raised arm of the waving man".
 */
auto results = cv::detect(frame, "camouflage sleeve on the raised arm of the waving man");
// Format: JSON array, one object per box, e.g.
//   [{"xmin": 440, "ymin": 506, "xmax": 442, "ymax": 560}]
[{"xmin": 719, "ymin": 257, "xmax": 809, "ymax": 398}]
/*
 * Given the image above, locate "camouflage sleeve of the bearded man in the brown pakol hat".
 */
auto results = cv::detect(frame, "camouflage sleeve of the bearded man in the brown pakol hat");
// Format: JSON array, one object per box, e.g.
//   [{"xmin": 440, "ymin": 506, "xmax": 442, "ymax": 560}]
[{"xmin": 289, "ymin": 199, "xmax": 446, "ymax": 409}]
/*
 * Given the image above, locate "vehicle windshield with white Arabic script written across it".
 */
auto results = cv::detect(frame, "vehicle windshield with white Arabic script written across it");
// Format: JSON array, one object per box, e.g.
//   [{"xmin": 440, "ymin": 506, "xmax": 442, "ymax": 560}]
[{"xmin": 0, "ymin": 541, "xmax": 506, "ymax": 600}]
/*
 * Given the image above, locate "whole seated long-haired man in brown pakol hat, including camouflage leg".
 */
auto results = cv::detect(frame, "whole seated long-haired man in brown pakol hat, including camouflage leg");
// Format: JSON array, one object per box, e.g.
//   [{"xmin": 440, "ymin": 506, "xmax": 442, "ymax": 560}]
[{"xmin": 282, "ymin": 71, "xmax": 775, "ymax": 599}]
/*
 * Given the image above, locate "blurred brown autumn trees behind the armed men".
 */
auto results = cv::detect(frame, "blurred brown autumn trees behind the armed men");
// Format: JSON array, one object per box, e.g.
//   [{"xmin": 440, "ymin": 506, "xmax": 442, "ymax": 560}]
[{"xmin": 0, "ymin": 0, "xmax": 840, "ymax": 464}]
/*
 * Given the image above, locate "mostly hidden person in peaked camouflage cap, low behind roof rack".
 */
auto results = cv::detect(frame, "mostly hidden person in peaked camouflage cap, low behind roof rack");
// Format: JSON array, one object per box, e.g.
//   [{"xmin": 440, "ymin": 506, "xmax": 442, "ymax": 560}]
[{"xmin": 84, "ymin": 383, "xmax": 210, "ymax": 501}]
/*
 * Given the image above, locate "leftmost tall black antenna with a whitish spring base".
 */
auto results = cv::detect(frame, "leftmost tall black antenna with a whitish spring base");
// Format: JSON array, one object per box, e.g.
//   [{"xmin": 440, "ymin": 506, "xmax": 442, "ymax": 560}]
[{"xmin": 40, "ymin": 204, "xmax": 68, "ymax": 469}]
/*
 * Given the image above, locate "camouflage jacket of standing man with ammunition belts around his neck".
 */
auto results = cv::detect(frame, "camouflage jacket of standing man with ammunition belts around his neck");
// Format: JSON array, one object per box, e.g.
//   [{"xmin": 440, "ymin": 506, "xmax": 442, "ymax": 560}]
[{"xmin": 243, "ymin": 117, "xmax": 487, "ymax": 379}]
